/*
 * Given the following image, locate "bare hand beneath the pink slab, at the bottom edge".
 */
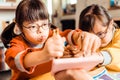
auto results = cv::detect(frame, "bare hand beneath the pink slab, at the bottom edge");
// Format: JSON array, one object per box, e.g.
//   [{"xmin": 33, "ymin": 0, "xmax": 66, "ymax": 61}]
[{"xmin": 54, "ymin": 69, "xmax": 93, "ymax": 80}]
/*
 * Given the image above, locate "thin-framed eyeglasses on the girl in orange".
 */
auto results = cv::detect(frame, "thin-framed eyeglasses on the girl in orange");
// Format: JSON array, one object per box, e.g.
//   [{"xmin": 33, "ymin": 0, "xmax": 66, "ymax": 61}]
[{"xmin": 23, "ymin": 23, "xmax": 51, "ymax": 32}]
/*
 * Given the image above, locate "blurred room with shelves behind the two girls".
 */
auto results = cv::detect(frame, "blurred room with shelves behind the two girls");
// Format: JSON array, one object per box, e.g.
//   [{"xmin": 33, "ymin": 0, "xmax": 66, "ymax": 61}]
[{"xmin": 0, "ymin": 0, "xmax": 120, "ymax": 80}]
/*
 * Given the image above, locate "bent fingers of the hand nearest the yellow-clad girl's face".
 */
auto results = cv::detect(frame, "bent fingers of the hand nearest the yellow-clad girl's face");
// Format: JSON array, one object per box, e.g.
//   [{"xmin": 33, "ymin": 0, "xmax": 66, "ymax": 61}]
[{"xmin": 81, "ymin": 32, "xmax": 101, "ymax": 56}]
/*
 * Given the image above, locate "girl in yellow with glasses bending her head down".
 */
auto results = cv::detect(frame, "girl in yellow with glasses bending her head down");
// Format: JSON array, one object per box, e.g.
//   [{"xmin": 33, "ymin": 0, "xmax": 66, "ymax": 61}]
[{"xmin": 79, "ymin": 4, "xmax": 120, "ymax": 80}]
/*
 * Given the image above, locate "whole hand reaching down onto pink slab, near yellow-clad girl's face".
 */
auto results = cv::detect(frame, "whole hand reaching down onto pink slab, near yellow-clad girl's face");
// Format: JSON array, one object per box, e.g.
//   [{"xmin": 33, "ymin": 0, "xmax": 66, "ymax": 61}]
[{"xmin": 74, "ymin": 31, "xmax": 101, "ymax": 55}]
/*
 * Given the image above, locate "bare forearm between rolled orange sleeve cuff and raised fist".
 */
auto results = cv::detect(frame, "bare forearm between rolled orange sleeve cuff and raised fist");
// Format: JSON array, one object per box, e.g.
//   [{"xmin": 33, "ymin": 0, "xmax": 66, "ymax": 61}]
[{"xmin": 24, "ymin": 51, "xmax": 50, "ymax": 68}]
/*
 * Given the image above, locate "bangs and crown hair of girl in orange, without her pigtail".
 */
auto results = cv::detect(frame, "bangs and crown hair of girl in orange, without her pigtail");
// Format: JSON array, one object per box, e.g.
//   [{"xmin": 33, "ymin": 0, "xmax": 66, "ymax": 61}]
[{"xmin": 15, "ymin": 0, "xmax": 49, "ymax": 28}]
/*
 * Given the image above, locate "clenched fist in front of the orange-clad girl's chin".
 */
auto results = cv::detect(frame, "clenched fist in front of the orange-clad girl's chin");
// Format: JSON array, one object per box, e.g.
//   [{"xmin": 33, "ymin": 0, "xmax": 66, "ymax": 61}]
[{"xmin": 44, "ymin": 29, "xmax": 65, "ymax": 57}]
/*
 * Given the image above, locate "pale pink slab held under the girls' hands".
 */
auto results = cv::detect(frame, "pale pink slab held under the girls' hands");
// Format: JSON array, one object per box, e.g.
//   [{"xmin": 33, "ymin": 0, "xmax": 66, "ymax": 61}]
[{"xmin": 51, "ymin": 54, "xmax": 103, "ymax": 74}]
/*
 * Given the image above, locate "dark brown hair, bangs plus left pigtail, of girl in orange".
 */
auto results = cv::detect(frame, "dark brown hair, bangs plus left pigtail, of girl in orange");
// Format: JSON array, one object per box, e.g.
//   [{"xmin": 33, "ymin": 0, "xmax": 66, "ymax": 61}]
[{"xmin": 1, "ymin": 0, "xmax": 49, "ymax": 48}]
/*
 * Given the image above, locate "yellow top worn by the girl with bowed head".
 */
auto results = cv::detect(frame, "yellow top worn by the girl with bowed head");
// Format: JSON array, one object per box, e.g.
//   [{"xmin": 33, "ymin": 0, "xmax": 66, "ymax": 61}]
[{"xmin": 101, "ymin": 29, "xmax": 120, "ymax": 72}]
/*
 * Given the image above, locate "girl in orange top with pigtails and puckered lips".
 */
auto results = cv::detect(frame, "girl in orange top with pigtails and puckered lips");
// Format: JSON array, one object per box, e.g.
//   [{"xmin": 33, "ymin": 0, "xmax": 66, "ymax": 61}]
[{"xmin": 1, "ymin": 0, "xmax": 100, "ymax": 80}]
